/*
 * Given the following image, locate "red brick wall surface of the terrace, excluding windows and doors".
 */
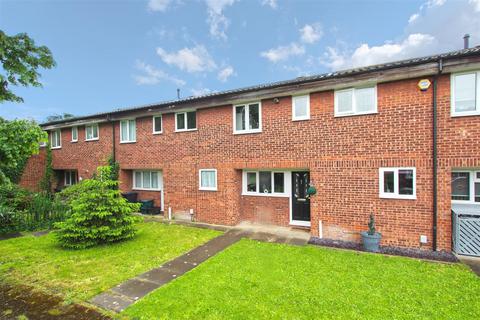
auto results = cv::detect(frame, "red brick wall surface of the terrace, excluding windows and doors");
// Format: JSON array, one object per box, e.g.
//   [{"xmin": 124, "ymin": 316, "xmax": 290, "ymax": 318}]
[{"xmin": 19, "ymin": 75, "xmax": 480, "ymax": 250}]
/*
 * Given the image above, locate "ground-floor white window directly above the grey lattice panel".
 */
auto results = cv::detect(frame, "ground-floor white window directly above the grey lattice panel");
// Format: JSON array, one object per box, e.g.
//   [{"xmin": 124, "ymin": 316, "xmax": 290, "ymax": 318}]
[{"xmin": 452, "ymin": 171, "xmax": 480, "ymax": 203}]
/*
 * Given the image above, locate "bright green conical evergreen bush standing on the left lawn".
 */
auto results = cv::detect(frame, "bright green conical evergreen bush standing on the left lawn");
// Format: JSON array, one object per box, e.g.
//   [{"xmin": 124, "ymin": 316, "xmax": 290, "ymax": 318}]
[{"xmin": 55, "ymin": 166, "xmax": 140, "ymax": 249}]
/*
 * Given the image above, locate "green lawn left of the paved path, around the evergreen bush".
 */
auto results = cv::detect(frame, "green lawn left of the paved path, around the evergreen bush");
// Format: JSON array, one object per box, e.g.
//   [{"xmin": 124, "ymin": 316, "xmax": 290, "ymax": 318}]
[{"xmin": 0, "ymin": 222, "xmax": 220, "ymax": 302}]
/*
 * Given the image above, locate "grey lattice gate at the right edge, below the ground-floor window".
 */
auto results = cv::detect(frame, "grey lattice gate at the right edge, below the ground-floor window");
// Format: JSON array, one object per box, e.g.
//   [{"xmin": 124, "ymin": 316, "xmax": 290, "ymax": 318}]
[{"xmin": 452, "ymin": 204, "xmax": 480, "ymax": 257}]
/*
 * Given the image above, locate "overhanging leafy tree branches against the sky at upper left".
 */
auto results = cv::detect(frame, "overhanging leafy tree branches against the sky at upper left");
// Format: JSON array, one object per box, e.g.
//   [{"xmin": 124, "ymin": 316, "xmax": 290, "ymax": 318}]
[{"xmin": 0, "ymin": 30, "xmax": 55, "ymax": 103}]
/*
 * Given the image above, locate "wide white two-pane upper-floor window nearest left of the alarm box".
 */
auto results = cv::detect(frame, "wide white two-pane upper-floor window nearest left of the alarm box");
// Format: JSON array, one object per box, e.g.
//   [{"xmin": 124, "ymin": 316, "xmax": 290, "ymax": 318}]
[{"xmin": 335, "ymin": 86, "xmax": 377, "ymax": 117}]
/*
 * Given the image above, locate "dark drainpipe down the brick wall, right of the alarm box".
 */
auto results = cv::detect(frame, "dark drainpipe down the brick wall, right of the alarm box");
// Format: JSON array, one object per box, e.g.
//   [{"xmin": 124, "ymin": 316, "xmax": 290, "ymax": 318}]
[{"xmin": 432, "ymin": 58, "xmax": 443, "ymax": 251}]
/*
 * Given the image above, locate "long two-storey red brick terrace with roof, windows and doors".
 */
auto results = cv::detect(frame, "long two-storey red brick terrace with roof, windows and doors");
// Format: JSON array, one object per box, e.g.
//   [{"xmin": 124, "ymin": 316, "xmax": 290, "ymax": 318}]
[{"xmin": 21, "ymin": 47, "xmax": 480, "ymax": 251}]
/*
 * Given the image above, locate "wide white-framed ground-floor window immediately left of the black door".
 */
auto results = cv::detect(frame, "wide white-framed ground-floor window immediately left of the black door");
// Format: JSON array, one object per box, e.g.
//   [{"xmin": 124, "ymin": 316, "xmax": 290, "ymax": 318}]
[{"xmin": 243, "ymin": 171, "xmax": 289, "ymax": 196}]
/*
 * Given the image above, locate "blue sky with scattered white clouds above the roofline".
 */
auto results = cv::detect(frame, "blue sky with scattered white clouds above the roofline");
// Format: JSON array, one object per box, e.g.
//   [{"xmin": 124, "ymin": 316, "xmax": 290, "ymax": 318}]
[{"xmin": 0, "ymin": 0, "xmax": 480, "ymax": 122}]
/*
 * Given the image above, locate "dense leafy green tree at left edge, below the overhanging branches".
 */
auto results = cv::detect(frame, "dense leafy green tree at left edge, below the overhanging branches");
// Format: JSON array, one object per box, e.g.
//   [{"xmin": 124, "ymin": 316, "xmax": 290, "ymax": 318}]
[{"xmin": 0, "ymin": 118, "xmax": 48, "ymax": 183}]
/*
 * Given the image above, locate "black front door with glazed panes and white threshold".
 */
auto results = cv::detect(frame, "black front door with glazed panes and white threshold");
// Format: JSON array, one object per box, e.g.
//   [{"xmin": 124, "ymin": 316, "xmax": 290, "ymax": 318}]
[{"xmin": 291, "ymin": 171, "xmax": 310, "ymax": 226}]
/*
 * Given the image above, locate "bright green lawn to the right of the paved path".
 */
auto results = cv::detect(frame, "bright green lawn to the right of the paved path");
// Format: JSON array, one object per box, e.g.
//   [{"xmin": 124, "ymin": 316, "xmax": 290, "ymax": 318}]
[{"xmin": 123, "ymin": 240, "xmax": 480, "ymax": 319}]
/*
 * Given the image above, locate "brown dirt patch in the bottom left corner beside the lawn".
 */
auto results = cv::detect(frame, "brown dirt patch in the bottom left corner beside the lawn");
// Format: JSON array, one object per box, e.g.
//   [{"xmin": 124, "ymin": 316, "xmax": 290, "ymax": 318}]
[{"xmin": 0, "ymin": 283, "xmax": 111, "ymax": 320}]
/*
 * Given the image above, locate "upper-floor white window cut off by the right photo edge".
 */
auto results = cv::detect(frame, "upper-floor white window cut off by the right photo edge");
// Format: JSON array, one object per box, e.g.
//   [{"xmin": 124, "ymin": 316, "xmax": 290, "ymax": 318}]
[{"xmin": 450, "ymin": 71, "xmax": 480, "ymax": 116}]
